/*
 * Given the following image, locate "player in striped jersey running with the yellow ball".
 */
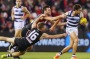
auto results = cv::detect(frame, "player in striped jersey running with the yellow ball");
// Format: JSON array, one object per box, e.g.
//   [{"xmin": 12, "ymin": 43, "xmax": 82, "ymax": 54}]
[{"xmin": 54, "ymin": 4, "xmax": 83, "ymax": 59}]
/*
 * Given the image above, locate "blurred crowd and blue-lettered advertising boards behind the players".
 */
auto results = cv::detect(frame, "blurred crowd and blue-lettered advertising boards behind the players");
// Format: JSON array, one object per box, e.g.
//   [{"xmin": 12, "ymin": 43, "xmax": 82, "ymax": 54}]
[{"xmin": 0, "ymin": 0, "xmax": 90, "ymax": 52}]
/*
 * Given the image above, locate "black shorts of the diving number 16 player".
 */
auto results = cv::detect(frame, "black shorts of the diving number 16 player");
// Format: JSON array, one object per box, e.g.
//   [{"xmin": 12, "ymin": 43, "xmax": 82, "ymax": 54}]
[{"xmin": 14, "ymin": 38, "xmax": 30, "ymax": 51}]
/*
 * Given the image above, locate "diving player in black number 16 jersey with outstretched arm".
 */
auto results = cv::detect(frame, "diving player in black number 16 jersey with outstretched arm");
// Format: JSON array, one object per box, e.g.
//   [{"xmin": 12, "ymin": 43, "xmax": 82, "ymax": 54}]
[{"xmin": 0, "ymin": 14, "xmax": 66, "ymax": 59}]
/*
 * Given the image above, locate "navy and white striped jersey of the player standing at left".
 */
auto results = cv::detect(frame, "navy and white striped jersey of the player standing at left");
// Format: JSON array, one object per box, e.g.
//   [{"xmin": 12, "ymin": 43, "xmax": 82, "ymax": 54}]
[{"xmin": 13, "ymin": 6, "xmax": 24, "ymax": 21}]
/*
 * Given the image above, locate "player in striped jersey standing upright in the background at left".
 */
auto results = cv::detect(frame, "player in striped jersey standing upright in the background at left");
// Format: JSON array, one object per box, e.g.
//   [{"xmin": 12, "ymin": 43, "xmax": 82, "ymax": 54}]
[{"xmin": 9, "ymin": 0, "xmax": 30, "ymax": 59}]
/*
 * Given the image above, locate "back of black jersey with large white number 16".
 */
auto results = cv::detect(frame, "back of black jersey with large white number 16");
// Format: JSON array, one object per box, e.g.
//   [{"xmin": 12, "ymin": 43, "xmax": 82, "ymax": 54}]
[{"xmin": 26, "ymin": 28, "xmax": 42, "ymax": 45}]
